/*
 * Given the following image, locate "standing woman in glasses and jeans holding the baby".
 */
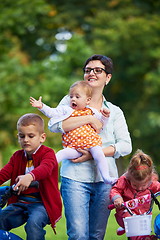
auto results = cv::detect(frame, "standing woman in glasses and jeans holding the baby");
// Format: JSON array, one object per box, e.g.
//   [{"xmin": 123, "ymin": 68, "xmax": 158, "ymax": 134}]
[{"xmin": 49, "ymin": 55, "xmax": 132, "ymax": 240}]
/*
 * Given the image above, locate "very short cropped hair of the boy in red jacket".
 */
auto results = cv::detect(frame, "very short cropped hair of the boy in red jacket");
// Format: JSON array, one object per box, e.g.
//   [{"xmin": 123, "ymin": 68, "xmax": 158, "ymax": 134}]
[{"xmin": 17, "ymin": 113, "xmax": 44, "ymax": 133}]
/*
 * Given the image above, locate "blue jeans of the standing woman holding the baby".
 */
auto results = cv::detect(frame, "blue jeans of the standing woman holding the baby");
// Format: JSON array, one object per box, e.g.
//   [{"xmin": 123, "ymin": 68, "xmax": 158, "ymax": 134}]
[{"xmin": 61, "ymin": 177, "xmax": 111, "ymax": 240}]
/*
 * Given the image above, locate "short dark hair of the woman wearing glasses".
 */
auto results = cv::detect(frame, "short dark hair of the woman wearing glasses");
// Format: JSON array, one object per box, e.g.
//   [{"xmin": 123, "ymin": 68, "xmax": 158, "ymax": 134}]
[{"xmin": 83, "ymin": 54, "xmax": 113, "ymax": 74}]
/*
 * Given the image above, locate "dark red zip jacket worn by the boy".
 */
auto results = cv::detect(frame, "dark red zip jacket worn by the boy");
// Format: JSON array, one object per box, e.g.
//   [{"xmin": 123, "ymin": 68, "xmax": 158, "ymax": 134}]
[{"xmin": 0, "ymin": 145, "xmax": 62, "ymax": 228}]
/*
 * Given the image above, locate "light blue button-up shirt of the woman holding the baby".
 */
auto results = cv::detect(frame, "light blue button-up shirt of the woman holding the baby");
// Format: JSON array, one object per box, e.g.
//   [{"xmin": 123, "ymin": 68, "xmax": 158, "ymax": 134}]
[{"xmin": 49, "ymin": 96, "xmax": 132, "ymax": 182}]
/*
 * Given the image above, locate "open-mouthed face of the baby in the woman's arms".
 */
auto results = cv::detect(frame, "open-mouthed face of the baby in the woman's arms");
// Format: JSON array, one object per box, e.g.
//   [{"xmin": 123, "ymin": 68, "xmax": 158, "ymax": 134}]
[{"xmin": 69, "ymin": 87, "xmax": 91, "ymax": 110}]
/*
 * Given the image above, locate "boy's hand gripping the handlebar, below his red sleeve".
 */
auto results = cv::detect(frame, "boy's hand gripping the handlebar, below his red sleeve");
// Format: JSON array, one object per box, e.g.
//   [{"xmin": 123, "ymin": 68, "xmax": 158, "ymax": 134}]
[{"xmin": 13, "ymin": 173, "xmax": 33, "ymax": 195}]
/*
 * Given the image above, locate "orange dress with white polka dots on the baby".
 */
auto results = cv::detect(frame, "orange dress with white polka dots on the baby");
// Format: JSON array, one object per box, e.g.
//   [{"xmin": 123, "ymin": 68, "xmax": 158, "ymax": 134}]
[{"xmin": 62, "ymin": 108, "xmax": 102, "ymax": 149}]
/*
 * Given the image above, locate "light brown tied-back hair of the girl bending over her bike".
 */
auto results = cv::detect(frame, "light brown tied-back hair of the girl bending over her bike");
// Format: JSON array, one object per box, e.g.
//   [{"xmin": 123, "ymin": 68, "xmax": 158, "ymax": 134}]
[{"xmin": 127, "ymin": 149, "xmax": 154, "ymax": 181}]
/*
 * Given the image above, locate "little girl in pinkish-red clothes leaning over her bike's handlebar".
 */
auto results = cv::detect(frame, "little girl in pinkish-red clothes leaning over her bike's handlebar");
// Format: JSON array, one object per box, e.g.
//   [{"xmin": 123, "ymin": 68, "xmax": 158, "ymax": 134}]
[{"xmin": 110, "ymin": 150, "xmax": 160, "ymax": 240}]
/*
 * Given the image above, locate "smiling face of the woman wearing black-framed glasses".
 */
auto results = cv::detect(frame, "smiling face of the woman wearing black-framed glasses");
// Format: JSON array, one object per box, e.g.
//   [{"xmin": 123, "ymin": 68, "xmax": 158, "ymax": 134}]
[{"xmin": 84, "ymin": 60, "xmax": 112, "ymax": 90}]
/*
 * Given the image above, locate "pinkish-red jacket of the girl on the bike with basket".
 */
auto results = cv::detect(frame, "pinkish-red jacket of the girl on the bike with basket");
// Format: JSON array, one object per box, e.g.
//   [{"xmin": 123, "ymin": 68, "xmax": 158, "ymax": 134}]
[{"xmin": 110, "ymin": 175, "xmax": 160, "ymax": 214}]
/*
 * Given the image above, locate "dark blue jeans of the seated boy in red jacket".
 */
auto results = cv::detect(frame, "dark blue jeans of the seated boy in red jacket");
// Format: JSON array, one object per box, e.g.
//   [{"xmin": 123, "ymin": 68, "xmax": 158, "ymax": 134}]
[{"xmin": 0, "ymin": 203, "xmax": 49, "ymax": 240}]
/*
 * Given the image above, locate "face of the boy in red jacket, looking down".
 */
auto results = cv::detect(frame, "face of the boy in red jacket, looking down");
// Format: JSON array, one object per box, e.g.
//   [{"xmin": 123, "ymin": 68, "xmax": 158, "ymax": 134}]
[{"xmin": 18, "ymin": 125, "xmax": 46, "ymax": 155}]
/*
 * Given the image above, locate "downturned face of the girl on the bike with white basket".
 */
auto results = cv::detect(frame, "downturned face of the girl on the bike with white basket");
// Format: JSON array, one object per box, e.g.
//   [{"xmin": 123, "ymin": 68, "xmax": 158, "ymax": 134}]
[{"xmin": 130, "ymin": 177, "xmax": 151, "ymax": 191}]
